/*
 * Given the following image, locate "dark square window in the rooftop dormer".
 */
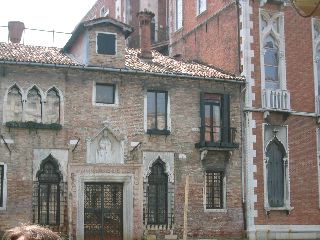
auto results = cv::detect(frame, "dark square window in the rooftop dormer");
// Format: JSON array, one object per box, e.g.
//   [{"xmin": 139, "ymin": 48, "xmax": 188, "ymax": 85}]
[{"xmin": 97, "ymin": 33, "xmax": 117, "ymax": 55}]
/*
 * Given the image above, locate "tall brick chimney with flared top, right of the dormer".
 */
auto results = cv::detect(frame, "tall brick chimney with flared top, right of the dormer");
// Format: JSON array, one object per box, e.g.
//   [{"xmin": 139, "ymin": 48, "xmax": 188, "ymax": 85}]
[{"xmin": 137, "ymin": 10, "xmax": 154, "ymax": 59}]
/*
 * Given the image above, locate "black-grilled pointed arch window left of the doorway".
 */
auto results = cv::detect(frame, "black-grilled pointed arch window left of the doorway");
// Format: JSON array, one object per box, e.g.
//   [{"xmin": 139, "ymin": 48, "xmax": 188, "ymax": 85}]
[{"xmin": 33, "ymin": 157, "xmax": 66, "ymax": 226}]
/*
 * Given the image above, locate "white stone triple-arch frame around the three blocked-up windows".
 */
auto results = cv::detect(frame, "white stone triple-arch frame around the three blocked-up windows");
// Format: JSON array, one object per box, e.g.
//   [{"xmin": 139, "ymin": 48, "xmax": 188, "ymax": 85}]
[{"xmin": 2, "ymin": 83, "xmax": 64, "ymax": 125}]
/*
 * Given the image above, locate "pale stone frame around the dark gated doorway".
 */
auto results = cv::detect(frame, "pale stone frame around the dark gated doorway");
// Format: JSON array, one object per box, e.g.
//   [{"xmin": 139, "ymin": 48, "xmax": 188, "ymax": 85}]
[{"xmin": 76, "ymin": 173, "xmax": 133, "ymax": 240}]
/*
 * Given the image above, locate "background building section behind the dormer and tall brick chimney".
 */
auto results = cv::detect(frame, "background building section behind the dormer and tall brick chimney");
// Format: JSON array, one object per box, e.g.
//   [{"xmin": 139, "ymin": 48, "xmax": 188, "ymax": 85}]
[{"xmin": 83, "ymin": 0, "xmax": 169, "ymax": 55}]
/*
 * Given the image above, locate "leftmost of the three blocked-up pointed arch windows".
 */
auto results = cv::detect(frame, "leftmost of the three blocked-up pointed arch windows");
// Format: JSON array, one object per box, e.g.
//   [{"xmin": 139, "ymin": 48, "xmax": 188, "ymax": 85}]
[{"xmin": 7, "ymin": 85, "xmax": 23, "ymax": 121}]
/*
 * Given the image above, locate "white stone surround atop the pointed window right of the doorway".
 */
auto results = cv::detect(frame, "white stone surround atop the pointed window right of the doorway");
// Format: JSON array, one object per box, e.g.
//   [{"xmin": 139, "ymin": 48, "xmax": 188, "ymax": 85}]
[{"xmin": 143, "ymin": 152, "xmax": 174, "ymax": 183}]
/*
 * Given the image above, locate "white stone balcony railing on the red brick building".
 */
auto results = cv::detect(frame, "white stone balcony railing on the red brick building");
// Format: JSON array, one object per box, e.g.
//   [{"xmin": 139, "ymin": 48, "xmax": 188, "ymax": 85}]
[{"xmin": 262, "ymin": 89, "xmax": 290, "ymax": 111}]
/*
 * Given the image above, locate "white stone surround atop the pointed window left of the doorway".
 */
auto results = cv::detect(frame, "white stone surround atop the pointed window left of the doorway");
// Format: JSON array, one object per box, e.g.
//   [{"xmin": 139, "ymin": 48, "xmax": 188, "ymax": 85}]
[{"xmin": 32, "ymin": 149, "xmax": 69, "ymax": 182}]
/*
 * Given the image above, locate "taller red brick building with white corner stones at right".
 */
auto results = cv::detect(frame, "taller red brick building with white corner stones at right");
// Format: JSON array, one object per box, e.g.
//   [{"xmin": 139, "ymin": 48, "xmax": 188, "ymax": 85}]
[{"xmin": 169, "ymin": 0, "xmax": 320, "ymax": 239}]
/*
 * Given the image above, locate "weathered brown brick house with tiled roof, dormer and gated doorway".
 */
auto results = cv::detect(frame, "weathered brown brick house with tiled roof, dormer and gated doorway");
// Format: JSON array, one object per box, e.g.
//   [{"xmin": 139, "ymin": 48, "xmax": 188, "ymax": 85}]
[{"xmin": 0, "ymin": 12, "xmax": 244, "ymax": 240}]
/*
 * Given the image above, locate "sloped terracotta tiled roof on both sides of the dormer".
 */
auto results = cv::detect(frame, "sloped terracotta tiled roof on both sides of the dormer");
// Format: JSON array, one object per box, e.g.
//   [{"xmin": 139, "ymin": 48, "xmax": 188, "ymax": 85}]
[{"xmin": 0, "ymin": 43, "xmax": 244, "ymax": 81}]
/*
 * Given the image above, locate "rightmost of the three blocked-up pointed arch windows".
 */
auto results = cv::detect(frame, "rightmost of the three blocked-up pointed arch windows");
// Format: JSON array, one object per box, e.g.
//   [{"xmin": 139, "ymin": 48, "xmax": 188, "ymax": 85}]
[{"xmin": 44, "ymin": 88, "xmax": 61, "ymax": 123}]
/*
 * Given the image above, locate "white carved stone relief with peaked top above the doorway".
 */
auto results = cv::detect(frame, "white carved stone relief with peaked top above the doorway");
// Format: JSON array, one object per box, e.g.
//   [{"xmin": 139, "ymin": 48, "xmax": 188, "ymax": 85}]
[{"xmin": 86, "ymin": 126, "xmax": 124, "ymax": 164}]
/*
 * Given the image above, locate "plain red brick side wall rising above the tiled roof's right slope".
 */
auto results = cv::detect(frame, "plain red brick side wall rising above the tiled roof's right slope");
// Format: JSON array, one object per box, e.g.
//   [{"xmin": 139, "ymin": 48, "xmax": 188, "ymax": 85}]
[{"xmin": 170, "ymin": 0, "xmax": 239, "ymax": 73}]
